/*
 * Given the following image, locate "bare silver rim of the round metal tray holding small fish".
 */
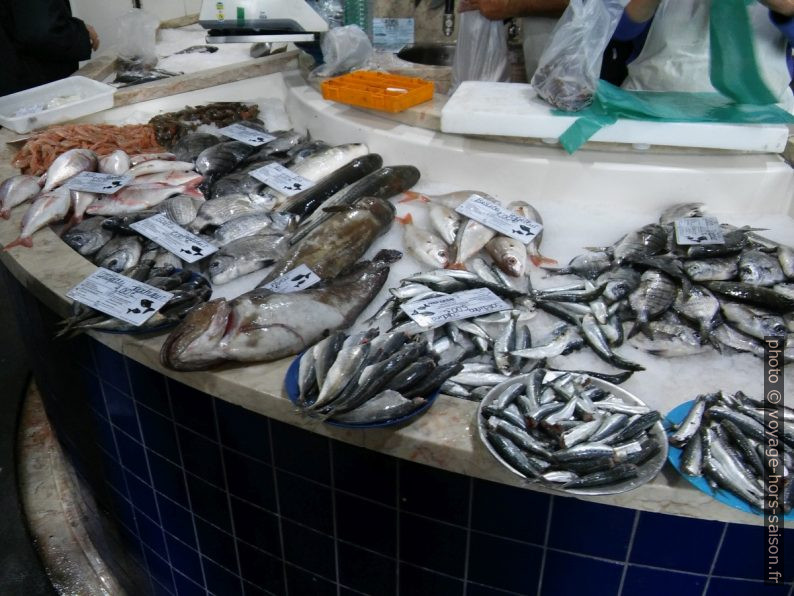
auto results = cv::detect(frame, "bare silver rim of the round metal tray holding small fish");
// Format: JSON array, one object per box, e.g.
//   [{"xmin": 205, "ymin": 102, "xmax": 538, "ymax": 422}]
[{"xmin": 477, "ymin": 373, "xmax": 667, "ymax": 496}]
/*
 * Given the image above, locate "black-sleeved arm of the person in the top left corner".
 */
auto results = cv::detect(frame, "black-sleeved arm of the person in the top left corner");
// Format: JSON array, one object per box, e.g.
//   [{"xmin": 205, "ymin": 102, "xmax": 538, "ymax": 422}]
[{"xmin": 9, "ymin": 0, "xmax": 92, "ymax": 61}]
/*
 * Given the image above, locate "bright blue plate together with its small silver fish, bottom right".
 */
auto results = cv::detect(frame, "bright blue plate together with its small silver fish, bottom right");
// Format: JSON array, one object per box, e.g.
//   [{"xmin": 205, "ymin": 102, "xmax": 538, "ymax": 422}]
[{"xmin": 665, "ymin": 391, "xmax": 794, "ymax": 520}]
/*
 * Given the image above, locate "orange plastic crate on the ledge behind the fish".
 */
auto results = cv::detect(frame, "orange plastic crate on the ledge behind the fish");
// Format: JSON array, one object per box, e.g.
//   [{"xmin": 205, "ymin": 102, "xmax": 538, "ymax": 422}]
[{"xmin": 321, "ymin": 70, "xmax": 434, "ymax": 112}]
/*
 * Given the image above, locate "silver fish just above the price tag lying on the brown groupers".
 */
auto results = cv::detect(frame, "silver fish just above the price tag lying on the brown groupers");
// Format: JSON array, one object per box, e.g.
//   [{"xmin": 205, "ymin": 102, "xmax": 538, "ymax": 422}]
[{"xmin": 207, "ymin": 234, "xmax": 289, "ymax": 284}]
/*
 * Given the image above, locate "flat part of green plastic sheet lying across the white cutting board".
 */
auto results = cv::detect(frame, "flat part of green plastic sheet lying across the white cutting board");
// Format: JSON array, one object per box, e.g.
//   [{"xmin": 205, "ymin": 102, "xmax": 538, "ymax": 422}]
[{"xmin": 552, "ymin": 81, "xmax": 794, "ymax": 153}]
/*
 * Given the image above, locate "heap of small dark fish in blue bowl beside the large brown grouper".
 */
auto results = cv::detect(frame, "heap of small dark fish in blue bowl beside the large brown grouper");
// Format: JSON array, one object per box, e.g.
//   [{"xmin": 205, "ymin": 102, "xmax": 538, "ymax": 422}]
[{"xmin": 297, "ymin": 329, "xmax": 462, "ymax": 424}]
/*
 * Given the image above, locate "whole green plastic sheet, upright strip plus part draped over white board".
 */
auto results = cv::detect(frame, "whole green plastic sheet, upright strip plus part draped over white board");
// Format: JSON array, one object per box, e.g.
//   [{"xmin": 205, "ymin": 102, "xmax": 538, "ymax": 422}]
[{"xmin": 552, "ymin": 0, "xmax": 794, "ymax": 153}]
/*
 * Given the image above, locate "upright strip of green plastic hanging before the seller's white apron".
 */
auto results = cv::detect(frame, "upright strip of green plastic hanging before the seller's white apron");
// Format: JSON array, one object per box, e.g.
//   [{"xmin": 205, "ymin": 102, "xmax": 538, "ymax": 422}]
[{"xmin": 709, "ymin": 0, "xmax": 777, "ymax": 104}]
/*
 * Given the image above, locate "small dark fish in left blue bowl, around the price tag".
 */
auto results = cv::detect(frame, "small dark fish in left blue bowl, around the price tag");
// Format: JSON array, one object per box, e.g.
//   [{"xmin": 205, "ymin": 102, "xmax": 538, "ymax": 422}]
[{"xmin": 57, "ymin": 259, "xmax": 212, "ymax": 337}]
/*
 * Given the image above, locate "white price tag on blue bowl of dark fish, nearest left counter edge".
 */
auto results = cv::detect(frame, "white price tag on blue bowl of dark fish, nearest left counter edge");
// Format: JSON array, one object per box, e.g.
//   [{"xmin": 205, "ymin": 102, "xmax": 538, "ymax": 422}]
[{"xmin": 66, "ymin": 267, "xmax": 174, "ymax": 327}]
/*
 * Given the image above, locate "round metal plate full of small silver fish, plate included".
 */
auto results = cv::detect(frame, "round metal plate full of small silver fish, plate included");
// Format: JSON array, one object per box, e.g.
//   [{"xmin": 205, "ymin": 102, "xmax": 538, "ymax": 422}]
[{"xmin": 477, "ymin": 368, "xmax": 667, "ymax": 495}]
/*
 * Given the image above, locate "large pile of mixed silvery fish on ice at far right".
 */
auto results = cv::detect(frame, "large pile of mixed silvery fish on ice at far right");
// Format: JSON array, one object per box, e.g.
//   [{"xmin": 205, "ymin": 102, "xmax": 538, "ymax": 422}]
[{"xmin": 536, "ymin": 203, "xmax": 794, "ymax": 362}]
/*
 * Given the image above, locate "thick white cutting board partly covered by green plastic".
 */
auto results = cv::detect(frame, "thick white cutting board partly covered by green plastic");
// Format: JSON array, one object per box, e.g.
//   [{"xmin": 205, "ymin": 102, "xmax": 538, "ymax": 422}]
[{"xmin": 441, "ymin": 81, "xmax": 789, "ymax": 153}]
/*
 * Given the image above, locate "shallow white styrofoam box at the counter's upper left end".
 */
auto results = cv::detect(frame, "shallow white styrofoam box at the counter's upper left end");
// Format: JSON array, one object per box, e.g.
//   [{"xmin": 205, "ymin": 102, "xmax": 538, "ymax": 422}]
[{"xmin": 0, "ymin": 76, "xmax": 116, "ymax": 133}]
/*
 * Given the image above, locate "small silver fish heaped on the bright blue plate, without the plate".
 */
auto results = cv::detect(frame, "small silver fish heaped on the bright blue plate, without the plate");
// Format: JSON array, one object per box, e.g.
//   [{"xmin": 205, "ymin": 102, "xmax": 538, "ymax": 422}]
[{"xmin": 669, "ymin": 391, "xmax": 794, "ymax": 513}]
